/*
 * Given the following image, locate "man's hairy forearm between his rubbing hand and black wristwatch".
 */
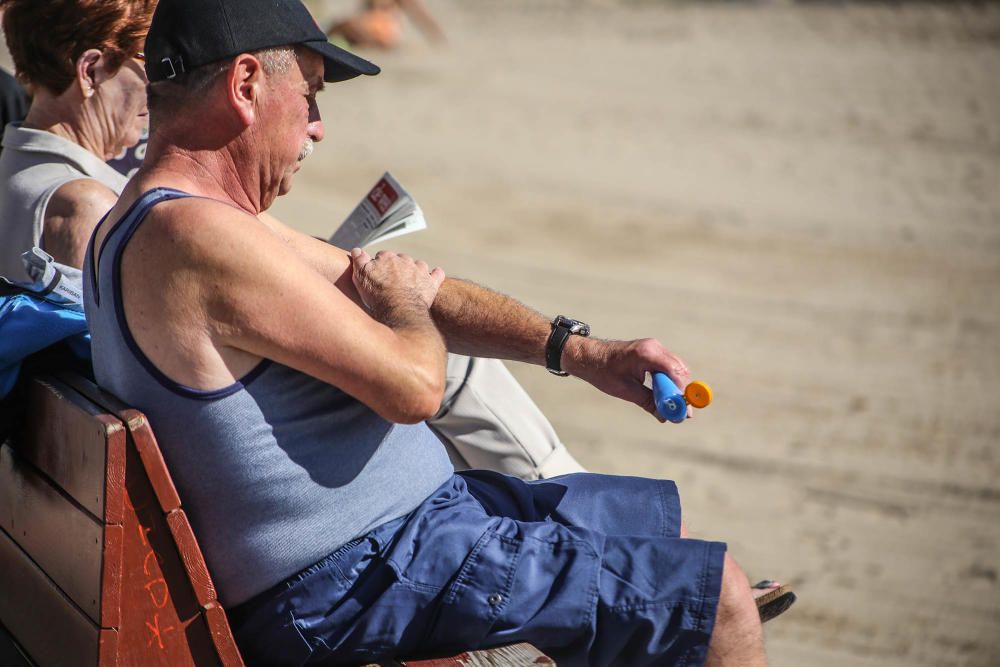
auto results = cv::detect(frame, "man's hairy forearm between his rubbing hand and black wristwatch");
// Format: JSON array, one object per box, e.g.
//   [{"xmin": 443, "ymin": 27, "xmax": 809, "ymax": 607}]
[{"xmin": 431, "ymin": 278, "xmax": 551, "ymax": 364}]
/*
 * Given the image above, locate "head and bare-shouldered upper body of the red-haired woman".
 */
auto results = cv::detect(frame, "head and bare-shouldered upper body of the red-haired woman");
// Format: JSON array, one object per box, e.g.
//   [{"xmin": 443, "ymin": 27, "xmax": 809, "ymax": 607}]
[{"xmin": 0, "ymin": 0, "xmax": 156, "ymax": 280}]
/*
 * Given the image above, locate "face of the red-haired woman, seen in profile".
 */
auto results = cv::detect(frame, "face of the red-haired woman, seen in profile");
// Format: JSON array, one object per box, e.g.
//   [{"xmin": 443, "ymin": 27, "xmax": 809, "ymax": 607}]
[{"xmin": 93, "ymin": 58, "xmax": 149, "ymax": 159}]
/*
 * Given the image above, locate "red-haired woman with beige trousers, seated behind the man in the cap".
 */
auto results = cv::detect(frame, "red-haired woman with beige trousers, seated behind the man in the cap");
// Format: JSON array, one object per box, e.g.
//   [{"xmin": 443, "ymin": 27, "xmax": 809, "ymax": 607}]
[{"xmin": 0, "ymin": 0, "xmax": 583, "ymax": 486}]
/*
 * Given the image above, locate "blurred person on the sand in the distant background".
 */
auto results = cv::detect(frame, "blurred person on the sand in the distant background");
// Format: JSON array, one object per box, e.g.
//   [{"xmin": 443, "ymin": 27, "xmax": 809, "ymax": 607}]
[{"xmin": 326, "ymin": 0, "xmax": 445, "ymax": 49}]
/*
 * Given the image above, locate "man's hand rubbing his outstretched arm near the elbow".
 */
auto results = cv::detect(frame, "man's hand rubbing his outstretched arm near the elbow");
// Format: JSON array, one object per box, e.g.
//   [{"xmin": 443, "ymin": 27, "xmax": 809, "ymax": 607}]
[{"xmin": 351, "ymin": 248, "xmax": 444, "ymax": 326}]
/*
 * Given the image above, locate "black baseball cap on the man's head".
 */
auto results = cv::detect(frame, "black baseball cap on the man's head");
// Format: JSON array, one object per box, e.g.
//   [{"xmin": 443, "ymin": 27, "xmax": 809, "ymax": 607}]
[{"xmin": 144, "ymin": 0, "xmax": 379, "ymax": 81}]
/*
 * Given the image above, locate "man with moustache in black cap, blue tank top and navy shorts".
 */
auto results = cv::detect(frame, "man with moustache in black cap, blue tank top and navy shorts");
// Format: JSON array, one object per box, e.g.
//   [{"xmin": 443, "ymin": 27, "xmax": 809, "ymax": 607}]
[{"xmin": 84, "ymin": 0, "xmax": 788, "ymax": 665}]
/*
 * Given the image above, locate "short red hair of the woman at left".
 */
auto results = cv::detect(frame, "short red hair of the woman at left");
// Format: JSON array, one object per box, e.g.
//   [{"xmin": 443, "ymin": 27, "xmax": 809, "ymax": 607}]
[{"xmin": 0, "ymin": 0, "xmax": 156, "ymax": 95}]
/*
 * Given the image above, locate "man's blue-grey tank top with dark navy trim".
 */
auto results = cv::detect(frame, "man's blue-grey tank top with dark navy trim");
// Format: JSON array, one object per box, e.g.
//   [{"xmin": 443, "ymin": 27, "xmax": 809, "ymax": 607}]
[{"xmin": 84, "ymin": 188, "xmax": 453, "ymax": 606}]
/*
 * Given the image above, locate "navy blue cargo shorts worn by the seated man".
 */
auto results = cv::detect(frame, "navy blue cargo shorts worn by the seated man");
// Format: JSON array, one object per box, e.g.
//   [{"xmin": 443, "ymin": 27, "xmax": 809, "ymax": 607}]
[{"xmin": 230, "ymin": 471, "xmax": 726, "ymax": 667}]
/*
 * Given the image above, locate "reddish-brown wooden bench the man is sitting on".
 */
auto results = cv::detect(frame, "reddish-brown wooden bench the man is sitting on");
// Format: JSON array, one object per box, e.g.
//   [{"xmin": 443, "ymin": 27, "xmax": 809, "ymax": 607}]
[{"xmin": 0, "ymin": 373, "xmax": 554, "ymax": 667}]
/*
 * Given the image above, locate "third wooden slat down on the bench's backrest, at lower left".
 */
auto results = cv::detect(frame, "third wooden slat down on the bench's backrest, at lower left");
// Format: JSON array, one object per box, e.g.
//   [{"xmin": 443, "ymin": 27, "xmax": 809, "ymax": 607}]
[{"xmin": 0, "ymin": 531, "xmax": 98, "ymax": 667}]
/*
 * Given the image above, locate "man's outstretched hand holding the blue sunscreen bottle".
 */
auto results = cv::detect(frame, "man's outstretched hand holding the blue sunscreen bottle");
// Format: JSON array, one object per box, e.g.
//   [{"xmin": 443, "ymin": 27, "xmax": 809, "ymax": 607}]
[{"xmin": 562, "ymin": 336, "xmax": 691, "ymax": 422}]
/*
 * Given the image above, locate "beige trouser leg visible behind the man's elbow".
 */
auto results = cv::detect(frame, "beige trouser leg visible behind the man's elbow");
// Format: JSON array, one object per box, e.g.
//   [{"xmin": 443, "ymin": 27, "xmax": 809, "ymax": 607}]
[{"xmin": 427, "ymin": 354, "xmax": 583, "ymax": 479}]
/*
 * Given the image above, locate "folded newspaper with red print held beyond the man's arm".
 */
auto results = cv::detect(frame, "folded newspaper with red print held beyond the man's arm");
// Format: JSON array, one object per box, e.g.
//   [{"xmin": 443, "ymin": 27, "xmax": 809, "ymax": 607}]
[{"xmin": 329, "ymin": 172, "xmax": 427, "ymax": 250}]
